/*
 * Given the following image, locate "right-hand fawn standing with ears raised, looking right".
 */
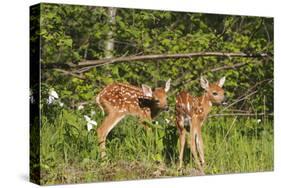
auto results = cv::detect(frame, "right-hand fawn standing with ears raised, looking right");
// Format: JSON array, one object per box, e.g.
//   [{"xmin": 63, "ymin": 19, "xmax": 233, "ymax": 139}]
[{"xmin": 176, "ymin": 77, "xmax": 225, "ymax": 173}]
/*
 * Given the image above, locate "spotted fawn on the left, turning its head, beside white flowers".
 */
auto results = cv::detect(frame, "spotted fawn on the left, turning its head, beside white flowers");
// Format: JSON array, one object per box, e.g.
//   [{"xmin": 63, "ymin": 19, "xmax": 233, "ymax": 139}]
[{"xmin": 96, "ymin": 79, "xmax": 171, "ymax": 158}]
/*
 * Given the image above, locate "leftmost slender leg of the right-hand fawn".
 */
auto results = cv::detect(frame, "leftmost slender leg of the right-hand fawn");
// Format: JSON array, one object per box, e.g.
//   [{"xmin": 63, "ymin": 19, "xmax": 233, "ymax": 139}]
[{"xmin": 176, "ymin": 115, "xmax": 186, "ymax": 168}]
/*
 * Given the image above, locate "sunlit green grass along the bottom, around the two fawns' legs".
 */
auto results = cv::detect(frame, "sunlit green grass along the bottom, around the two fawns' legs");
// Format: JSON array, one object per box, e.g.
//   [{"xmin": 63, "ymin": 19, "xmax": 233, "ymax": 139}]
[{"xmin": 31, "ymin": 110, "xmax": 274, "ymax": 184}]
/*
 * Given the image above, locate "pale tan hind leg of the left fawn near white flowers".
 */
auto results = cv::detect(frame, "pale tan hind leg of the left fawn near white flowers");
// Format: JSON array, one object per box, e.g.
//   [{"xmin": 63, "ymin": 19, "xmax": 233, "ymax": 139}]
[{"xmin": 97, "ymin": 112, "xmax": 125, "ymax": 158}]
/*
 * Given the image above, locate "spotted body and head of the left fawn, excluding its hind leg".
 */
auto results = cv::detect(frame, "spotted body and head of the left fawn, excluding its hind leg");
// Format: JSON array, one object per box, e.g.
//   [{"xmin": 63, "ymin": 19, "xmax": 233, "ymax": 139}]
[{"xmin": 96, "ymin": 81, "xmax": 170, "ymax": 119}]
